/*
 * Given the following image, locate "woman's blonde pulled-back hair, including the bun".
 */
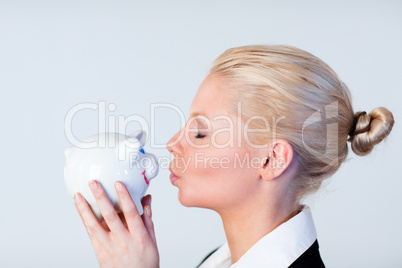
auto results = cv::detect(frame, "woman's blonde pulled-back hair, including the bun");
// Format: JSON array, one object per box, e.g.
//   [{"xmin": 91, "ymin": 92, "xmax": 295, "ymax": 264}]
[{"xmin": 210, "ymin": 45, "xmax": 394, "ymax": 200}]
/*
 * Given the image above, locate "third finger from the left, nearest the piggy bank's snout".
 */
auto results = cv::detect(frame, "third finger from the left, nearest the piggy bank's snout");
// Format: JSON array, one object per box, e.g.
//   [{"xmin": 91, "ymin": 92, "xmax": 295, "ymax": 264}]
[{"xmin": 115, "ymin": 181, "xmax": 145, "ymax": 238}]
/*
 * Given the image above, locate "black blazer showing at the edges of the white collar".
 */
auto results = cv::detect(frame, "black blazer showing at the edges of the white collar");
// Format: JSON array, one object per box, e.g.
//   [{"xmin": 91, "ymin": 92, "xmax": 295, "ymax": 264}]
[{"xmin": 197, "ymin": 240, "xmax": 325, "ymax": 268}]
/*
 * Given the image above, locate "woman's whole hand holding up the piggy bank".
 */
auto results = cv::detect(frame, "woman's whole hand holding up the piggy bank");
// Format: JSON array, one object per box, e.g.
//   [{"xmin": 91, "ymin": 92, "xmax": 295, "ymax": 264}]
[{"xmin": 74, "ymin": 181, "xmax": 159, "ymax": 268}]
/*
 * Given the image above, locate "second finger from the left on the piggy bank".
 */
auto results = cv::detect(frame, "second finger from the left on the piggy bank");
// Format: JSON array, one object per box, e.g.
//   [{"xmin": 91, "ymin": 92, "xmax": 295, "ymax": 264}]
[{"xmin": 89, "ymin": 180, "xmax": 127, "ymax": 235}]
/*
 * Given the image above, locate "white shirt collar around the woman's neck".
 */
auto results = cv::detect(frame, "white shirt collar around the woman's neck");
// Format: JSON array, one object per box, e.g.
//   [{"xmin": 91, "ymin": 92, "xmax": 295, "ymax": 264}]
[{"xmin": 199, "ymin": 205, "xmax": 317, "ymax": 268}]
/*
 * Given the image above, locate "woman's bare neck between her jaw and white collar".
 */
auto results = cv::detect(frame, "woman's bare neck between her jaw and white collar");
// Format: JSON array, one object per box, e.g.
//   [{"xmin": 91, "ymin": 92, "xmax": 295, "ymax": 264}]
[{"xmin": 219, "ymin": 197, "xmax": 299, "ymax": 264}]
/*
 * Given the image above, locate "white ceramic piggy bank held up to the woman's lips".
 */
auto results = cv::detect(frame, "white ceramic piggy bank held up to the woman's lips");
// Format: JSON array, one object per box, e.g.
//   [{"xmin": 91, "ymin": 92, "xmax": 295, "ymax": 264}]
[{"xmin": 64, "ymin": 130, "xmax": 159, "ymax": 220}]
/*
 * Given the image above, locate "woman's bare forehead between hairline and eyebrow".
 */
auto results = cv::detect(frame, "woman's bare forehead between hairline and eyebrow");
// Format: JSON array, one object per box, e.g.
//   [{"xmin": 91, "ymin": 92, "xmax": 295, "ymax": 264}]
[{"xmin": 190, "ymin": 76, "xmax": 230, "ymax": 119}]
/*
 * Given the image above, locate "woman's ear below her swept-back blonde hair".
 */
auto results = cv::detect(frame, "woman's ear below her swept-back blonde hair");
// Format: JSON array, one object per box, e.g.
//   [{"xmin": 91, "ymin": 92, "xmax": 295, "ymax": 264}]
[{"xmin": 259, "ymin": 139, "xmax": 293, "ymax": 181}]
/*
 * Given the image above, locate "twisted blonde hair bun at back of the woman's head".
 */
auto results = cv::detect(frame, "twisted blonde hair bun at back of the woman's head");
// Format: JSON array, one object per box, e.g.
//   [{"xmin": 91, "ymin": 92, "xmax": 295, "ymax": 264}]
[{"xmin": 348, "ymin": 107, "xmax": 395, "ymax": 156}]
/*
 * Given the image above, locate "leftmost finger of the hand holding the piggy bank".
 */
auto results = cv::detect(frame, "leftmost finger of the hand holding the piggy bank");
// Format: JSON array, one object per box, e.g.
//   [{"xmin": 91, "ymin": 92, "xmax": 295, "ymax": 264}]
[{"xmin": 74, "ymin": 193, "xmax": 108, "ymax": 243}]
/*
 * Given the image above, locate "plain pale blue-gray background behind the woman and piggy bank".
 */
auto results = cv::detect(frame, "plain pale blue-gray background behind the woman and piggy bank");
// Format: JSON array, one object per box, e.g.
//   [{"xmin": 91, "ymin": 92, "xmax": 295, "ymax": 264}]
[{"xmin": 0, "ymin": 0, "xmax": 402, "ymax": 267}]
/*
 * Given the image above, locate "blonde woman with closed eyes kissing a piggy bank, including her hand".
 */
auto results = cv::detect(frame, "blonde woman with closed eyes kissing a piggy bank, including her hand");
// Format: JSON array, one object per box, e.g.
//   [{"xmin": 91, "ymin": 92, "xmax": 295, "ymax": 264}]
[{"xmin": 75, "ymin": 46, "xmax": 394, "ymax": 268}]
